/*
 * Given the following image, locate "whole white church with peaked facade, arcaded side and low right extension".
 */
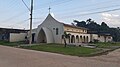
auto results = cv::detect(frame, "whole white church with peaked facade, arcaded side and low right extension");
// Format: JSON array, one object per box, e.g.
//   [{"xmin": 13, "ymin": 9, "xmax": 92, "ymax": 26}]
[{"xmin": 33, "ymin": 14, "xmax": 112, "ymax": 43}]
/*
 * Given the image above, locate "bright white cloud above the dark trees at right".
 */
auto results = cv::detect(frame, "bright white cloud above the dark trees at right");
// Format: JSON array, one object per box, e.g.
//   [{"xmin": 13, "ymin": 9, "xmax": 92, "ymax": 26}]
[{"xmin": 101, "ymin": 13, "xmax": 120, "ymax": 27}]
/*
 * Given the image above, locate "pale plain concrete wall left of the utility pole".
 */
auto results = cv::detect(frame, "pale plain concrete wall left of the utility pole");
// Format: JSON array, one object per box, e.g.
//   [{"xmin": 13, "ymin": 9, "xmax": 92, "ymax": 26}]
[{"xmin": 9, "ymin": 33, "xmax": 27, "ymax": 42}]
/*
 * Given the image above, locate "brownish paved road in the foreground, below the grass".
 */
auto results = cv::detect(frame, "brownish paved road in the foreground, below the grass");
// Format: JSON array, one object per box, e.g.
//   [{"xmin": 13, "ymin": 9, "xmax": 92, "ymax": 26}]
[{"xmin": 0, "ymin": 46, "xmax": 120, "ymax": 67}]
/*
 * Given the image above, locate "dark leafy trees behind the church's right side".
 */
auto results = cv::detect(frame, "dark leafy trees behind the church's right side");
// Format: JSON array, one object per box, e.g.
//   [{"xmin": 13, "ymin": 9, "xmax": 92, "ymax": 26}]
[{"xmin": 74, "ymin": 18, "xmax": 120, "ymax": 42}]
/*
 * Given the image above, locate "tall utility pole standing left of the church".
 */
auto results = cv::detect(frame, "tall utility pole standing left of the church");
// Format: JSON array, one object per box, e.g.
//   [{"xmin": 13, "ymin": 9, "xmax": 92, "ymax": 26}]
[{"xmin": 29, "ymin": 0, "xmax": 33, "ymax": 44}]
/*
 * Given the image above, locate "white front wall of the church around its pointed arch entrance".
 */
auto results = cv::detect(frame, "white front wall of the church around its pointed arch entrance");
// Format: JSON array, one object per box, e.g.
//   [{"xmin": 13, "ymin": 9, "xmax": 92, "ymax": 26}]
[{"xmin": 35, "ymin": 14, "xmax": 64, "ymax": 43}]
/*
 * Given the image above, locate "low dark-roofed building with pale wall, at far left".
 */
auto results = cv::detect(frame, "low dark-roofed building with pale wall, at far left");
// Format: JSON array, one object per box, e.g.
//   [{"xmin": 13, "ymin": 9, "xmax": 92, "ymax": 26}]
[{"xmin": 0, "ymin": 28, "xmax": 28, "ymax": 42}]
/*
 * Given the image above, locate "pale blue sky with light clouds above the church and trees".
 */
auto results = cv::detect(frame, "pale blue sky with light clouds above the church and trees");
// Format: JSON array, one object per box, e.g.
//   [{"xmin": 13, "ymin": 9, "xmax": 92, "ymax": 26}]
[{"xmin": 0, "ymin": 0, "xmax": 120, "ymax": 29}]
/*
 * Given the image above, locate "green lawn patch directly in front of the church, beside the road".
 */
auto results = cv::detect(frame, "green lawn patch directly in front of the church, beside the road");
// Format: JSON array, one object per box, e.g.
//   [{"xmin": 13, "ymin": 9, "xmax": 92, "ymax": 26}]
[{"xmin": 21, "ymin": 44, "xmax": 100, "ymax": 56}]
